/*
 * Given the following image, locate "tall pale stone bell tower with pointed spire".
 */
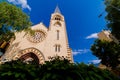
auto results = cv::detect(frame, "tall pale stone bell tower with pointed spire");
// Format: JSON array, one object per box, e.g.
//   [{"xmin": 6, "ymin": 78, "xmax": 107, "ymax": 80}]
[{"xmin": 44, "ymin": 6, "xmax": 73, "ymax": 62}]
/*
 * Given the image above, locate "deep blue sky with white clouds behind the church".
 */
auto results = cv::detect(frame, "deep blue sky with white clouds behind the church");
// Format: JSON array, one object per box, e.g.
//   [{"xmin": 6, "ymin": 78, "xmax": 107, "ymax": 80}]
[{"xmin": 8, "ymin": 0, "xmax": 106, "ymax": 63}]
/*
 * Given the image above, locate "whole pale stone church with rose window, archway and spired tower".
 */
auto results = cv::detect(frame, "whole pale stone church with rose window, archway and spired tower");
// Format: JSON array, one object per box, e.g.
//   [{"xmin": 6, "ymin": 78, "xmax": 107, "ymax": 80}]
[{"xmin": 1, "ymin": 7, "xmax": 73, "ymax": 64}]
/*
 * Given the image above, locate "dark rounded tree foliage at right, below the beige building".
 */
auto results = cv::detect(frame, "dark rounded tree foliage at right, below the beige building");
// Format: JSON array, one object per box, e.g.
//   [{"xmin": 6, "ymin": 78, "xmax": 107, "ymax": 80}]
[{"xmin": 91, "ymin": 40, "xmax": 120, "ymax": 68}]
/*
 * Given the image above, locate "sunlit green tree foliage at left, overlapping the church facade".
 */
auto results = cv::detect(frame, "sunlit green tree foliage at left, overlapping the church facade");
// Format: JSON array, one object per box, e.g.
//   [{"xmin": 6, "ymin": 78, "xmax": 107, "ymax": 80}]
[{"xmin": 0, "ymin": 2, "xmax": 31, "ymax": 41}]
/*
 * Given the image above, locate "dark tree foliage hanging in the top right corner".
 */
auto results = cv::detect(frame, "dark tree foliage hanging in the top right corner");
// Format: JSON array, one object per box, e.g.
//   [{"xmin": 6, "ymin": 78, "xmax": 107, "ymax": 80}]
[{"xmin": 105, "ymin": 0, "xmax": 120, "ymax": 40}]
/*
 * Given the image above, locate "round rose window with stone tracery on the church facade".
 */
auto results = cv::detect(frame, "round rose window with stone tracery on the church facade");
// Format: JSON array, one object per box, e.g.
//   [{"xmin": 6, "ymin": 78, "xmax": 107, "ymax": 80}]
[{"xmin": 28, "ymin": 30, "xmax": 46, "ymax": 43}]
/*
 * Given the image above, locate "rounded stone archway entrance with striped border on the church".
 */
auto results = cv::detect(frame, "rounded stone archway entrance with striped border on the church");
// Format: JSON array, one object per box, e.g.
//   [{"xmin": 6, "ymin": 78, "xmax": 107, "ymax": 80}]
[{"xmin": 14, "ymin": 48, "xmax": 45, "ymax": 64}]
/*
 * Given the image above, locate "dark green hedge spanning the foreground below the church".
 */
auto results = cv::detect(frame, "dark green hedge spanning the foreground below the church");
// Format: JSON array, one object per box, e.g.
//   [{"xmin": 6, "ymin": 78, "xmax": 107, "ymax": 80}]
[{"xmin": 0, "ymin": 57, "xmax": 119, "ymax": 80}]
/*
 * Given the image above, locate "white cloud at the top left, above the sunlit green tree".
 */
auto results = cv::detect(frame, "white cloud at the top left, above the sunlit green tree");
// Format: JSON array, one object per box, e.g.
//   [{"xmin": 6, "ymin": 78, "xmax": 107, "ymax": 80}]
[{"xmin": 8, "ymin": 0, "xmax": 31, "ymax": 11}]
